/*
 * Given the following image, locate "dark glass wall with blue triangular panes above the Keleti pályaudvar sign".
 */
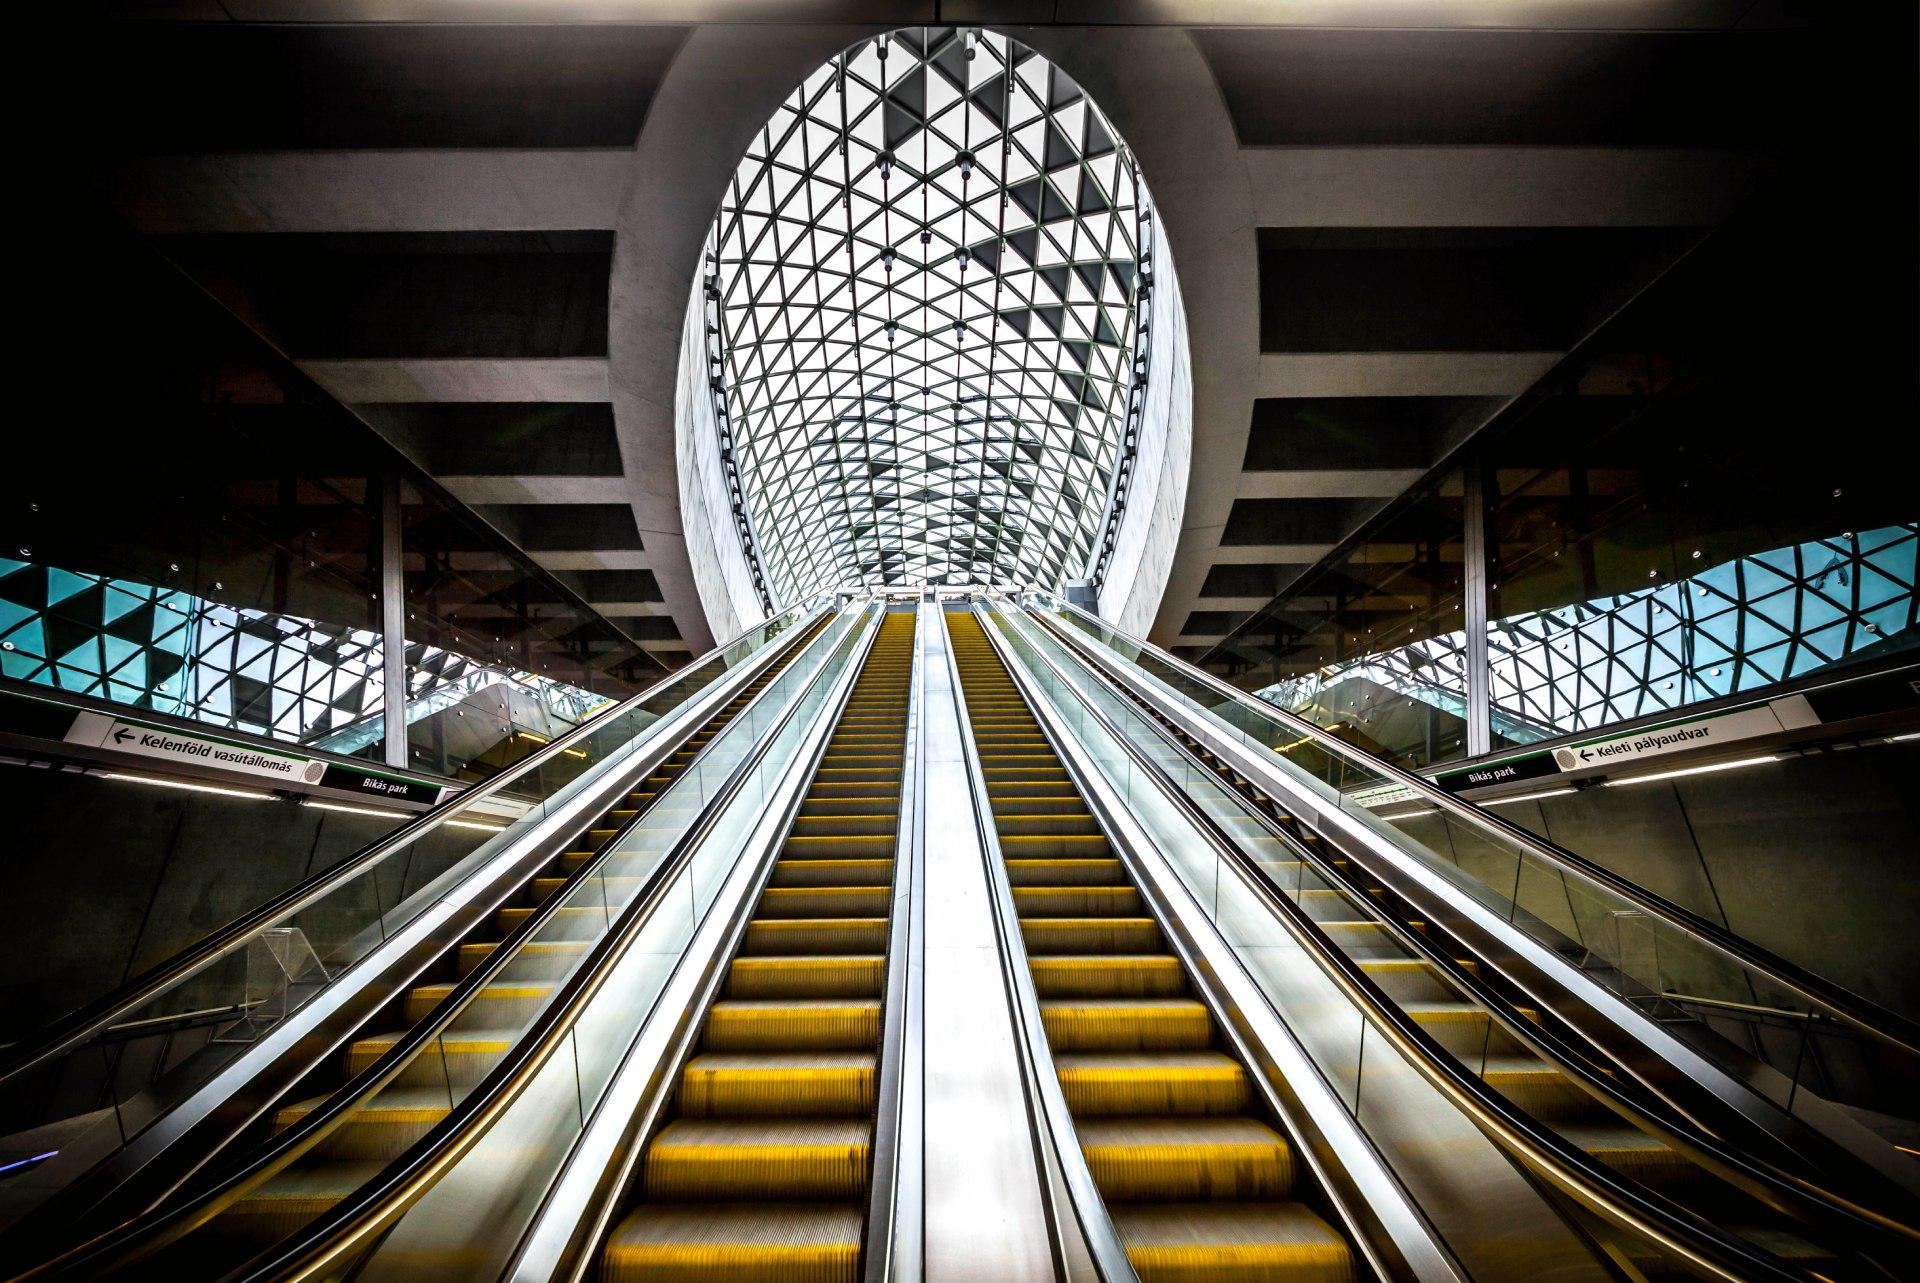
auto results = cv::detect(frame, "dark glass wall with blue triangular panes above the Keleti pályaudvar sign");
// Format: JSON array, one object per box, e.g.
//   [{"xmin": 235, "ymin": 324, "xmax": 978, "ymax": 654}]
[{"xmin": 1204, "ymin": 179, "xmax": 1920, "ymax": 766}]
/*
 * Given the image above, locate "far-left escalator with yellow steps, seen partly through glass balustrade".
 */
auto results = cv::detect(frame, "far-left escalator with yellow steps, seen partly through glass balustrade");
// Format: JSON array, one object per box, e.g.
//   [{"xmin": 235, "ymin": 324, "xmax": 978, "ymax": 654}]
[{"xmin": 133, "ymin": 618, "xmax": 828, "ymax": 1268}]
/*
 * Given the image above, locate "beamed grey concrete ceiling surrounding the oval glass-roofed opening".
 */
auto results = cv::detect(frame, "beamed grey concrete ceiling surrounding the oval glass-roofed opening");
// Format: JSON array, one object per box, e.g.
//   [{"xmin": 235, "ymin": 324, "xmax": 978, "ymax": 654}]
[{"xmin": 94, "ymin": 0, "xmax": 1858, "ymax": 663}]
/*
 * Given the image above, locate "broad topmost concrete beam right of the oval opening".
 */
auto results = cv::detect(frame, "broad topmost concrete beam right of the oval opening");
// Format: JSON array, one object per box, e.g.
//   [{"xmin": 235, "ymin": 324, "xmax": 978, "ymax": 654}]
[{"xmin": 1240, "ymin": 146, "xmax": 1764, "ymax": 227}]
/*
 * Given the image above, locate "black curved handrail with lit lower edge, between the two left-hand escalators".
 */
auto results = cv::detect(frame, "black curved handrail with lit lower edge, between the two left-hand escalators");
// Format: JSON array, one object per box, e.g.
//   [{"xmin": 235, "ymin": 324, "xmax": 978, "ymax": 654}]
[{"xmin": 225, "ymin": 603, "xmax": 874, "ymax": 1281}]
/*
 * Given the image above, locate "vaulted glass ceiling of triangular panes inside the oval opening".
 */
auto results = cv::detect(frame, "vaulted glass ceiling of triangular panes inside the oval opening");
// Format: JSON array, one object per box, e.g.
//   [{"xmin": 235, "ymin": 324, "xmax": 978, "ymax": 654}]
[{"xmin": 707, "ymin": 27, "xmax": 1150, "ymax": 605}]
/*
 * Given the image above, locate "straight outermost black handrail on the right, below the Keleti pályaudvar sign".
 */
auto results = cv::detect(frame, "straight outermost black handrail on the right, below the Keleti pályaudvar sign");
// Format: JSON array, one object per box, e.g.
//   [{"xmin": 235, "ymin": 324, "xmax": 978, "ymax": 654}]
[{"xmin": 1033, "ymin": 593, "xmax": 1920, "ymax": 1058}]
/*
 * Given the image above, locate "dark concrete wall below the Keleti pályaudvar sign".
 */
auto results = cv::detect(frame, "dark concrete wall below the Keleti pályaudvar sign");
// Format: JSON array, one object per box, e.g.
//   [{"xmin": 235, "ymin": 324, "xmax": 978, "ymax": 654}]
[{"xmin": 1402, "ymin": 743, "xmax": 1920, "ymax": 1018}]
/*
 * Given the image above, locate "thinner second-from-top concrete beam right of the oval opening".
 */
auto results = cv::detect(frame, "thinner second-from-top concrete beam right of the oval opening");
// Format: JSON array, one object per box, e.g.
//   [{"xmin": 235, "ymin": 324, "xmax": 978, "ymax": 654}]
[{"xmin": 1258, "ymin": 351, "xmax": 1565, "ymax": 396}]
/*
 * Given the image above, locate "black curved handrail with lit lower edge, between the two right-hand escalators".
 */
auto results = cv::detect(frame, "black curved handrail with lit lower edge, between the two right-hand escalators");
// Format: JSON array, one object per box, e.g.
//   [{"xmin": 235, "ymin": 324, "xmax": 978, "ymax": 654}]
[{"xmin": 990, "ymin": 606, "xmax": 1843, "ymax": 1283}]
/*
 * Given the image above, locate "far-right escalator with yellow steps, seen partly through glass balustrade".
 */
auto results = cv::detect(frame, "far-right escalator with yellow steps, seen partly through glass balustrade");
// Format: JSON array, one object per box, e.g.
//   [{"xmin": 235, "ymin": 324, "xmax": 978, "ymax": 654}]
[{"xmin": 1006, "ymin": 603, "xmax": 1912, "ymax": 1279}]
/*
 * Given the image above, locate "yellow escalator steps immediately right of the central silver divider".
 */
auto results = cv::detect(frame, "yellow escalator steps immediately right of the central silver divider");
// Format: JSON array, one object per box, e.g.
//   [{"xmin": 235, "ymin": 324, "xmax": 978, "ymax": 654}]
[{"xmin": 947, "ymin": 613, "xmax": 1361, "ymax": 1283}]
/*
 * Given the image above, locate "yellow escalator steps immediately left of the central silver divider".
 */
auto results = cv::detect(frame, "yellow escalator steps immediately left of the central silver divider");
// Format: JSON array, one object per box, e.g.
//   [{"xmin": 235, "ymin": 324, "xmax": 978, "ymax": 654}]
[{"xmin": 601, "ymin": 611, "xmax": 916, "ymax": 1281}]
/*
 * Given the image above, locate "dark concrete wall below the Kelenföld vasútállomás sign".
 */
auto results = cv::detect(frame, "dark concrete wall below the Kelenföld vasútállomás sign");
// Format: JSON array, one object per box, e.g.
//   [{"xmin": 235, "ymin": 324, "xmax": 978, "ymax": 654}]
[{"xmin": 0, "ymin": 766, "xmax": 490, "ymax": 1039}]
